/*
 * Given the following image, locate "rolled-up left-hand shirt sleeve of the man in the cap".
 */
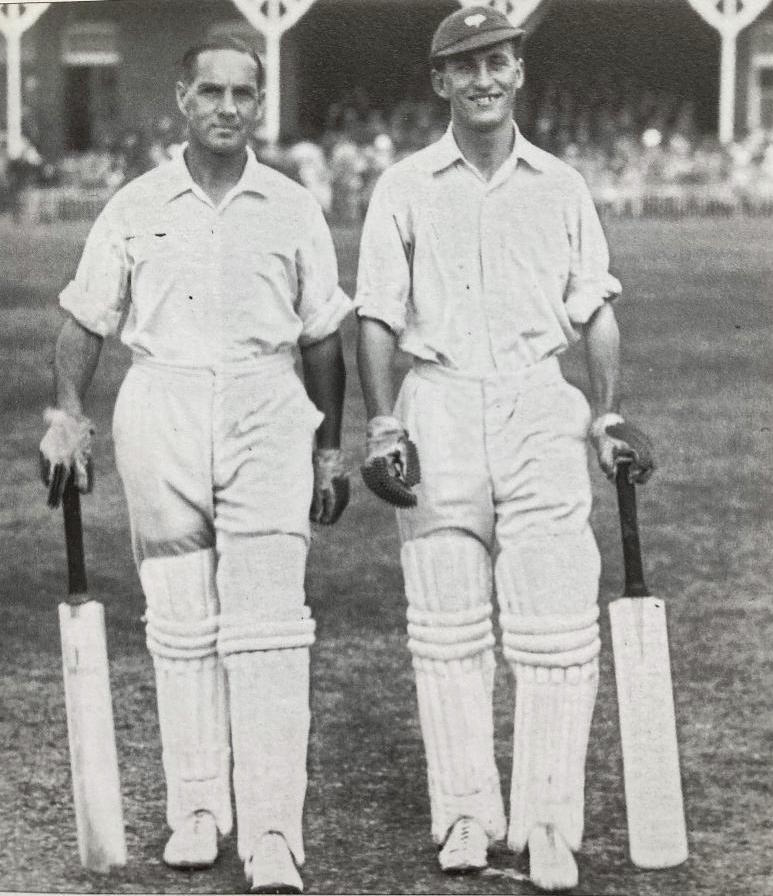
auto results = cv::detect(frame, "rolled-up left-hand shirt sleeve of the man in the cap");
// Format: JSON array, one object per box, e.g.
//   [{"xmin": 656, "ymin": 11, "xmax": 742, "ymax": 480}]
[{"xmin": 354, "ymin": 176, "xmax": 413, "ymax": 336}]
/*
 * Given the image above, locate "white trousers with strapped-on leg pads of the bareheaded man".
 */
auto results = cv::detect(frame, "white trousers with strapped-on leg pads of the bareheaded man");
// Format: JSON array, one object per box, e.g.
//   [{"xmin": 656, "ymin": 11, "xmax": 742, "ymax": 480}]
[{"xmin": 113, "ymin": 354, "xmax": 322, "ymax": 863}]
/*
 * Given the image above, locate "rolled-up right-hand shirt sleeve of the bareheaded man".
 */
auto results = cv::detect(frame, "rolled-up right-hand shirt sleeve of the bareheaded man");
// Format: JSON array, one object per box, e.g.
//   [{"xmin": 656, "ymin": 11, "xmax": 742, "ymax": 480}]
[{"xmin": 296, "ymin": 202, "xmax": 352, "ymax": 345}]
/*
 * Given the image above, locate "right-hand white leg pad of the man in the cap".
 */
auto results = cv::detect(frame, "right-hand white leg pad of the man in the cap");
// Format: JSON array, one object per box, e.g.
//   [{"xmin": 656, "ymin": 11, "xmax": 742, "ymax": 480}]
[{"xmin": 497, "ymin": 536, "xmax": 601, "ymax": 851}]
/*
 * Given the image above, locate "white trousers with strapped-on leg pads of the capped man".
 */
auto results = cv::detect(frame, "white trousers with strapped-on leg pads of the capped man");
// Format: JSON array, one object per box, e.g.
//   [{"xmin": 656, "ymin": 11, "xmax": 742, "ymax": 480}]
[{"xmin": 395, "ymin": 359, "xmax": 600, "ymax": 850}]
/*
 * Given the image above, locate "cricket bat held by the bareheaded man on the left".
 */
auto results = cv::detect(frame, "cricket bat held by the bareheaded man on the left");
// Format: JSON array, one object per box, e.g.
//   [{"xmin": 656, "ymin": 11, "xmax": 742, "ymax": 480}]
[{"xmin": 59, "ymin": 477, "xmax": 126, "ymax": 873}]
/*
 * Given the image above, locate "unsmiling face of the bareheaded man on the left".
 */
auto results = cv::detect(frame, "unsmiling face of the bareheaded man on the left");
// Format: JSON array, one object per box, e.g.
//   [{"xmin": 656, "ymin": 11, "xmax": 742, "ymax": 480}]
[{"xmin": 177, "ymin": 50, "xmax": 263, "ymax": 155}]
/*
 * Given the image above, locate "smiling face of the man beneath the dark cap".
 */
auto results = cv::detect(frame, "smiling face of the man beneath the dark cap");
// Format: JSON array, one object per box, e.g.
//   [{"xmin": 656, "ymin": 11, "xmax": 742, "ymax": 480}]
[{"xmin": 432, "ymin": 41, "xmax": 523, "ymax": 131}]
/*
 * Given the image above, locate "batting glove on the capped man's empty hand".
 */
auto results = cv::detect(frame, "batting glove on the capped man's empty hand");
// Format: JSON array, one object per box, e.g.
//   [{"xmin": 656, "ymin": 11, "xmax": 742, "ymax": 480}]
[{"xmin": 361, "ymin": 415, "xmax": 421, "ymax": 507}]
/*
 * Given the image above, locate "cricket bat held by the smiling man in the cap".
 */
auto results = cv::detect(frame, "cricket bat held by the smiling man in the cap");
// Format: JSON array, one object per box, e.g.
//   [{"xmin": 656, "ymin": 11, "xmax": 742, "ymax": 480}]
[{"xmin": 609, "ymin": 464, "xmax": 688, "ymax": 868}]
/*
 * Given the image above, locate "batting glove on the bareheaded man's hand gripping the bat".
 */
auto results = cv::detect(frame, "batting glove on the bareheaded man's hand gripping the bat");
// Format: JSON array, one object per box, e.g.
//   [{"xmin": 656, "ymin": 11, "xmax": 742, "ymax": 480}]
[{"xmin": 40, "ymin": 408, "xmax": 94, "ymax": 507}]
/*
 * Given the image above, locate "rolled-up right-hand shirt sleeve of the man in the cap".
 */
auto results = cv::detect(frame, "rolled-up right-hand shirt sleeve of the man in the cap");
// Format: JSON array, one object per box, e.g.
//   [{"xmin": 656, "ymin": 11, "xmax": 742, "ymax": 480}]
[{"xmin": 564, "ymin": 175, "xmax": 622, "ymax": 324}]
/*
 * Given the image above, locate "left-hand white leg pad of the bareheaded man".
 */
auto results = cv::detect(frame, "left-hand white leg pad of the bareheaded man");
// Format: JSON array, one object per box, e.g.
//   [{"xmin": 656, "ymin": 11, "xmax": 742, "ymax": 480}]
[{"xmin": 140, "ymin": 550, "xmax": 233, "ymax": 834}]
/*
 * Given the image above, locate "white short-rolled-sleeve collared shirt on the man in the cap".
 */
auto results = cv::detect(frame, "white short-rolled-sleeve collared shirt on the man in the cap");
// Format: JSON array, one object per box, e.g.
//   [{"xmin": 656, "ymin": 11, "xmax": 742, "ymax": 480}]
[{"xmin": 355, "ymin": 127, "xmax": 620, "ymax": 375}]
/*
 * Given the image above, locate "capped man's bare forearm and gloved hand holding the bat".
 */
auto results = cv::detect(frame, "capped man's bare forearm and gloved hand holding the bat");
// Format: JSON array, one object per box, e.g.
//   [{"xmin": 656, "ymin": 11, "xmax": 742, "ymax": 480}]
[{"xmin": 583, "ymin": 302, "xmax": 655, "ymax": 483}]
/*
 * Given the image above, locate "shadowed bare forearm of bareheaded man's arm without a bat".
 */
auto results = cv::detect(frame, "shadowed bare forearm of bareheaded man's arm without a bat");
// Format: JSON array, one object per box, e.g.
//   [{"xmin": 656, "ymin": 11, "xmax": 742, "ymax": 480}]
[{"xmin": 301, "ymin": 332, "xmax": 346, "ymax": 448}]
